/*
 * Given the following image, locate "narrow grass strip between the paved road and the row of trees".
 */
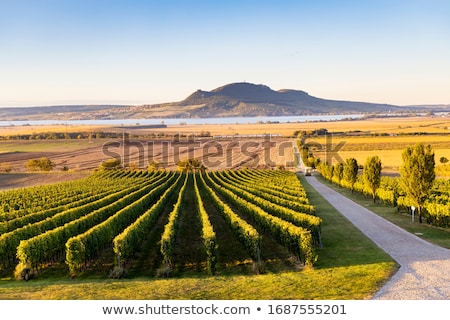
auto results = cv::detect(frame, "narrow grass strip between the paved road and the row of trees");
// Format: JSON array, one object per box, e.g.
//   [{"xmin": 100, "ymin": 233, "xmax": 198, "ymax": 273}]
[{"xmin": 318, "ymin": 176, "xmax": 450, "ymax": 249}]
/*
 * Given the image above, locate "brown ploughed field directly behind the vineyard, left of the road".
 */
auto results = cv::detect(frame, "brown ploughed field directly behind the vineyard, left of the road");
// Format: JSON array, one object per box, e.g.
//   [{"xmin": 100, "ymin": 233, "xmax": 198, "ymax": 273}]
[{"xmin": 0, "ymin": 137, "xmax": 295, "ymax": 173}]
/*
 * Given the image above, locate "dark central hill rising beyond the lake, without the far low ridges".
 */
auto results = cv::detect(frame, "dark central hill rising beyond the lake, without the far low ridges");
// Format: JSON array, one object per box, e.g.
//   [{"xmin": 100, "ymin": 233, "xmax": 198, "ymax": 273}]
[{"xmin": 159, "ymin": 82, "xmax": 404, "ymax": 117}]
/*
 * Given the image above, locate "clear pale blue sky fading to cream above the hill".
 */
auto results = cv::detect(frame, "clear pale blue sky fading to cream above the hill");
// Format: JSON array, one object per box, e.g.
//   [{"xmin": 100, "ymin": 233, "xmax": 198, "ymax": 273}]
[{"xmin": 0, "ymin": 0, "xmax": 450, "ymax": 107}]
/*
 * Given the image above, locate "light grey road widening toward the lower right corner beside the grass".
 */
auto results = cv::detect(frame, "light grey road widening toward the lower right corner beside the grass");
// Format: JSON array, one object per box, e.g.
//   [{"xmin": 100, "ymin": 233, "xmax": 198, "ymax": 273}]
[{"xmin": 306, "ymin": 176, "xmax": 450, "ymax": 300}]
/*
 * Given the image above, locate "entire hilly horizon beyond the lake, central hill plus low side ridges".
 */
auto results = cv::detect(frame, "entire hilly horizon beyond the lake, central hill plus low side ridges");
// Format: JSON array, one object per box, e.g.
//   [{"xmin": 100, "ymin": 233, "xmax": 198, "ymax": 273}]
[{"xmin": 0, "ymin": 82, "xmax": 450, "ymax": 121}]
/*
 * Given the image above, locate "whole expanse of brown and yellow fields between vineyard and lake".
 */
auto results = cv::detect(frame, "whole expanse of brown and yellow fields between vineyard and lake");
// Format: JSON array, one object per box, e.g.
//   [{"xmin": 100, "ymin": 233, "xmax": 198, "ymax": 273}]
[{"xmin": 0, "ymin": 117, "xmax": 450, "ymax": 176}]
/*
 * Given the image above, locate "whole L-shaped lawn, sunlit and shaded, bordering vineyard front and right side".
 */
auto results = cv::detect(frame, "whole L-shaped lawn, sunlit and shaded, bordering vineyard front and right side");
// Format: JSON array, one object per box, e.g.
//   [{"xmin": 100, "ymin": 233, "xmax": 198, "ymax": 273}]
[{"xmin": 0, "ymin": 172, "xmax": 398, "ymax": 300}]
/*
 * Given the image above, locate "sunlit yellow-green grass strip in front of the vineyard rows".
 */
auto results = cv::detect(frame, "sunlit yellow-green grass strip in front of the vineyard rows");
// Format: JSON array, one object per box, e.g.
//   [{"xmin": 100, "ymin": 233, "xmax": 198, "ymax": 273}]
[{"xmin": 0, "ymin": 262, "xmax": 392, "ymax": 300}]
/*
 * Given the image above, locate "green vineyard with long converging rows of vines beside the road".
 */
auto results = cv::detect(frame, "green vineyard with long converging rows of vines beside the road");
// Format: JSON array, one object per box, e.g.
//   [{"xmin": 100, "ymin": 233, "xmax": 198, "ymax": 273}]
[{"xmin": 0, "ymin": 169, "xmax": 321, "ymax": 279}]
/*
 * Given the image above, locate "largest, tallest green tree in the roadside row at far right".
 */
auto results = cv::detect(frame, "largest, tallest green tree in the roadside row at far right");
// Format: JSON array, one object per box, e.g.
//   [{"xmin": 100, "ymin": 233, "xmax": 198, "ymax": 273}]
[{"xmin": 400, "ymin": 143, "xmax": 436, "ymax": 223}]
